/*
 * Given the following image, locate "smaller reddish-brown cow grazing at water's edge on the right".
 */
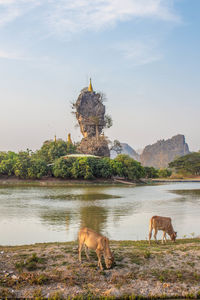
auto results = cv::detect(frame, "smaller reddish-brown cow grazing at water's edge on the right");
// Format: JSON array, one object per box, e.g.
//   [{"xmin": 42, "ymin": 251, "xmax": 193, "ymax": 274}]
[{"xmin": 149, "ymin": 216, "xmax": 177, "ymax": 244}]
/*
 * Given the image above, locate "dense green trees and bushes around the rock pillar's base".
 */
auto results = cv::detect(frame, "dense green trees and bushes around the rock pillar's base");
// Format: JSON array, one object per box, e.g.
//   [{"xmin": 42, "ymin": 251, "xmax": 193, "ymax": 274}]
[{"xmin": 0, "ymin": 140, "xmax": 172, "ymax": 180}]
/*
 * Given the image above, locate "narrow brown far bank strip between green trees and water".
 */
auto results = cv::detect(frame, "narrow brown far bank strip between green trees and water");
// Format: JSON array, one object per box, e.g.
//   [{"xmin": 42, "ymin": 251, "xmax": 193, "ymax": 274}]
[{"xmin": 0, "ymin": 177, "xmax": 139, "ymax": 187}]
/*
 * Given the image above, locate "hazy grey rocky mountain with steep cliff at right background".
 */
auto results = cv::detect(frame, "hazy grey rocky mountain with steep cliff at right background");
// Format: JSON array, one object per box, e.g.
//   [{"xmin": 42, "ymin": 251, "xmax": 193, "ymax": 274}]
[{"xmin": 140, "ymin": 134, "xmax": 190, "ymax": 168}]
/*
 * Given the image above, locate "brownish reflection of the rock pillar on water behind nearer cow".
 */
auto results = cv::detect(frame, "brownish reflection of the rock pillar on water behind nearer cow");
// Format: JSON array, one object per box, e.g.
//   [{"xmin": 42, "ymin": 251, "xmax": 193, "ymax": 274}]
[{"xmin": 80, "ymin": 206, "xmax": 108, "ymax": 233}]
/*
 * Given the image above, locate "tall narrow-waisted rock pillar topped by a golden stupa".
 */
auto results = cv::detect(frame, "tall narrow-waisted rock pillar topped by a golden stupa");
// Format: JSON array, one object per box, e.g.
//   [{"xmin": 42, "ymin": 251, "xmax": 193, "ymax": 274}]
[{"xmin": 73, "ymin": 81, "xmax": 110, "ymax": 156}]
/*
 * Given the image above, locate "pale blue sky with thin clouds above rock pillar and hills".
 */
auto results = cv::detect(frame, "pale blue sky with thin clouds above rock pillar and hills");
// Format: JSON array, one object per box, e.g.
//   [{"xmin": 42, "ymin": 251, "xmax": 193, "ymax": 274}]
[{"xmin": 0, "ymin": 0, "xmax": 200, "ymax": 151}]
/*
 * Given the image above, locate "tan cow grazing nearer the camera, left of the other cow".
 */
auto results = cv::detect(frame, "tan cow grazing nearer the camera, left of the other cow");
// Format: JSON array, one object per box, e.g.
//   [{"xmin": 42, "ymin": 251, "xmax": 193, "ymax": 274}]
[{"xmin": 78, "ymin": 227, "xmax": 114, "ymax": 270}]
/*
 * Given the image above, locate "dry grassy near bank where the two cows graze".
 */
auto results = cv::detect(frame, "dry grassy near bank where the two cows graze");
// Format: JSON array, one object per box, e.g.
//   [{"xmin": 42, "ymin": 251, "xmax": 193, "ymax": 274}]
[{"xmin": 0, "ymin": 238, "xmax": 200, "ymax": 299}]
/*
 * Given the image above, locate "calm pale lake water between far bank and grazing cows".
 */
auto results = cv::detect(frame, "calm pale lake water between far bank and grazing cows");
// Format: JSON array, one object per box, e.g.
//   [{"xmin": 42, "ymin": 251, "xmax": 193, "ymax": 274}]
[{"xmin": 0, "ymin": 183, "xmax": 200, "ymax": 245}]
